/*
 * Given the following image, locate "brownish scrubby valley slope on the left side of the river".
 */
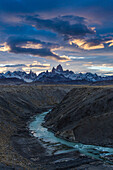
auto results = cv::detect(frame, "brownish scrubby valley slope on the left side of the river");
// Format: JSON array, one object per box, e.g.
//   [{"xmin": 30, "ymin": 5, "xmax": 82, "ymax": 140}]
[{"xmin": 0, "ymin": 85, "xmax": 72, "ymax": 169}]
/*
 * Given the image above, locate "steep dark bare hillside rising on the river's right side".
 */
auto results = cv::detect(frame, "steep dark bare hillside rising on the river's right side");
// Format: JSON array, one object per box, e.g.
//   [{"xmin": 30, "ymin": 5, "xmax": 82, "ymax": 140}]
[{"xmin": 45, "ymin": 87, "xmax": 113, "ymax": 146}]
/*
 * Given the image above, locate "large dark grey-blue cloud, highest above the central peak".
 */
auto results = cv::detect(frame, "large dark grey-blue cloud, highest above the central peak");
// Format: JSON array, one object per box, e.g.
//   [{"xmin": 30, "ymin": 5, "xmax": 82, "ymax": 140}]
[{"xmin": 26, "ymin": 16, "xmax": 95, "ymax": 38}]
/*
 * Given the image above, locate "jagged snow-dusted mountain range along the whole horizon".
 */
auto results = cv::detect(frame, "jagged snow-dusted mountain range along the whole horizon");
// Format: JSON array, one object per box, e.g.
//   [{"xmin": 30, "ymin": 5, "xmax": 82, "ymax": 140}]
[{"xmin": 0, "ymin": 64, "xmax": 113, "ymax": 83}]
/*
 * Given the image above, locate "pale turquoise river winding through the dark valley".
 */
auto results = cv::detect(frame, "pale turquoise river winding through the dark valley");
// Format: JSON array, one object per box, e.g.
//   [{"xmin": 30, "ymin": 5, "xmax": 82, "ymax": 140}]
[{"xmin": 29, "ymin": 110, "xmax": 113, "ymax": 164}]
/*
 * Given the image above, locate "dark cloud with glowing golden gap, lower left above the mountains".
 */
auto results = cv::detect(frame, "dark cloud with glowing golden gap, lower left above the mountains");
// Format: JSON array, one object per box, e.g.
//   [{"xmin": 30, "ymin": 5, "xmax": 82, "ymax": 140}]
[{"xmin": 7, "ymin": 37, "xmax": 66, "ymax": 60}]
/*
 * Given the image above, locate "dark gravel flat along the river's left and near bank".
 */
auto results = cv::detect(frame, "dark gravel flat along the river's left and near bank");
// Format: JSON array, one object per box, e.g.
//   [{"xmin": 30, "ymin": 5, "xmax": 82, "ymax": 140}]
[{"xmin": 12, "ymin": 108, "xmax": 109, "ymax": 170}]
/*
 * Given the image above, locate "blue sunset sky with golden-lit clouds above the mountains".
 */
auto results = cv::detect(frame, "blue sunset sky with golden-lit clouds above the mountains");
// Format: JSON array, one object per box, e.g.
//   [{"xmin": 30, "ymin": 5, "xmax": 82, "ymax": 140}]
[{"xmin": 0, "ymin": 0, "xmax": 113, "ymax": 75}]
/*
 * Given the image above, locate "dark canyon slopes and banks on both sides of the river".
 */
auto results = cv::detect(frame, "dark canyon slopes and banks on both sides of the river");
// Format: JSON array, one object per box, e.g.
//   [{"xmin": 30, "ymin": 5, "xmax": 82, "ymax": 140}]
[{"xmin": 0, "ymin": 84, "xmax": 113, "ymax": 170}]
